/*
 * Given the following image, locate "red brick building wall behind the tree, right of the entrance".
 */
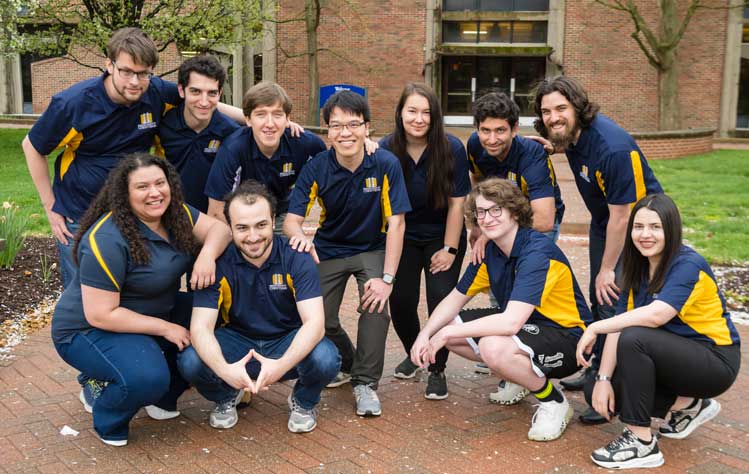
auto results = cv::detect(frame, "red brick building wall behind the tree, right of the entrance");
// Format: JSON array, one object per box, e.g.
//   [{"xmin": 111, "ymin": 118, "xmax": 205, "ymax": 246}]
[{"xmin": 564, "ymin": 0, "xmax": 728, "ymax": 131}]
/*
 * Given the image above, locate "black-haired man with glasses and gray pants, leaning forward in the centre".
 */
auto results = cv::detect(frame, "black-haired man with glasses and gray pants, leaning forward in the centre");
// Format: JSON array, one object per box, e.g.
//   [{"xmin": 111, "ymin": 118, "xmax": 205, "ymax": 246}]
[{"xmin": 284, "ymin": 91, "xmax": 411, "ymax": 416}]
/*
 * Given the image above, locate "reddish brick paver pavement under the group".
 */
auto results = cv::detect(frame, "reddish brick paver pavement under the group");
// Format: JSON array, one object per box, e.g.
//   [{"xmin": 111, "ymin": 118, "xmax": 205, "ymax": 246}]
[{"xmin": 0, "ymin": 159, "xmax": 749, "ymax": 473}]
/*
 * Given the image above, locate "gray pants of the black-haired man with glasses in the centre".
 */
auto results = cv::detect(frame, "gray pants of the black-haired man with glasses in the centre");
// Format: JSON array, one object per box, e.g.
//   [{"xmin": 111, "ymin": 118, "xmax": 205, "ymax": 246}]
[{"xmin": 317, "ymin": 250, "xmax": 390, "ymax": 388}]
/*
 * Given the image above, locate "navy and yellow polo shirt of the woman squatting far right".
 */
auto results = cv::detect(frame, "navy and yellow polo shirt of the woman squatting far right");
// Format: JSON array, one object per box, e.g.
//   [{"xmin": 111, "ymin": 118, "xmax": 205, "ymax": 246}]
[{"xmin": 616, "ymin": 245, "xmax": 739, "ymax": 346}]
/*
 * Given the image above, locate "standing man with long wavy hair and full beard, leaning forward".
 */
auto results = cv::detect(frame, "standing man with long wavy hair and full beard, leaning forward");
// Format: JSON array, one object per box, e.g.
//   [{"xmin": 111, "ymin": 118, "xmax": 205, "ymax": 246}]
[{"xmin": 534, "ymin": 76, "xmax": 663, "ymax": 423}]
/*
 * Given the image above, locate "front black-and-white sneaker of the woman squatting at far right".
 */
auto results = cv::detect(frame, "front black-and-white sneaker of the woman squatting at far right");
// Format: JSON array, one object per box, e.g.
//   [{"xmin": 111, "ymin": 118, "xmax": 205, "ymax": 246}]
[{"xmin": 590, "ymin": 428, "xmax": 663, "ymax": 469}]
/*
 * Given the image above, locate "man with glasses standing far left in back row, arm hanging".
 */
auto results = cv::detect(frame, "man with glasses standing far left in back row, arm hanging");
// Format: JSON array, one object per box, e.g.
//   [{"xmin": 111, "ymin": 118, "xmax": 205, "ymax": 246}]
[{"xmin": 22, "ymin": 28, "xmax": 179, "ymax": 287}]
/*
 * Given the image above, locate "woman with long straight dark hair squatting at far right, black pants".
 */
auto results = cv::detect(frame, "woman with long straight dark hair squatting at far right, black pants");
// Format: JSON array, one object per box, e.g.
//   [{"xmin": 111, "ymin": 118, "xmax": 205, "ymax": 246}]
[{"xmin": 577, "ymin": 194, "xmax": 741, "ymax": 468}]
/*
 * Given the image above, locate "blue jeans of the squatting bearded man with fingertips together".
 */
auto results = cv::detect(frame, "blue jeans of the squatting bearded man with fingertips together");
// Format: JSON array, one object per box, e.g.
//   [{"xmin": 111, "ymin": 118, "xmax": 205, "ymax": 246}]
[{"xmin": 177, "ymin": 327, "xmax": 341, "ymax": 409}]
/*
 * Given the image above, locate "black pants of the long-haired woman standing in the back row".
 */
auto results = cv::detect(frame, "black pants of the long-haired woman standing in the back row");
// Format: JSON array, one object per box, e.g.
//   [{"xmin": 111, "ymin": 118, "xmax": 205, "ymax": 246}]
[{"xmin": 390, "ymin": 238, "xmax": 466, "ymax": 372}]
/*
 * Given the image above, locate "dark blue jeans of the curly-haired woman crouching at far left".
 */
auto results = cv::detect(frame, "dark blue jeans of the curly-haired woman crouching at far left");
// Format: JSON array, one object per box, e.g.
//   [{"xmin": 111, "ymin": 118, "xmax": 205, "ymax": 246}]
[{"xmin": 55, "ymin": 293, "xmax": 192, "ymax": 440}]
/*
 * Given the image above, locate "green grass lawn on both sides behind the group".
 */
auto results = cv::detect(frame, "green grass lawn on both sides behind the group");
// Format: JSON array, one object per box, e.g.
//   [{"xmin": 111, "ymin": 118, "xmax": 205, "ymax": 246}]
[{"xmin": 0, "ymin": 129, "xmax": 749, "ymax": 263}]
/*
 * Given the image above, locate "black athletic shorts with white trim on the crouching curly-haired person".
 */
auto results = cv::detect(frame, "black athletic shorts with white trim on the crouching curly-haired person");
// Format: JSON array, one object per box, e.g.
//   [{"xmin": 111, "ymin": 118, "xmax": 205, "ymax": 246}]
[{"xmin": 455, "ymin": 308, "xmax": 579, "ymax": 379}]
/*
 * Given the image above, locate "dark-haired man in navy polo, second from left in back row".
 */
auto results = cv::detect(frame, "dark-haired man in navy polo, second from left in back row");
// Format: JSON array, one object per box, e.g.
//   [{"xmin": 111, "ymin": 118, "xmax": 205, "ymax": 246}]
[{"xmin": 156, "ymin": 55, "xmax": 239, "ymax": 213}]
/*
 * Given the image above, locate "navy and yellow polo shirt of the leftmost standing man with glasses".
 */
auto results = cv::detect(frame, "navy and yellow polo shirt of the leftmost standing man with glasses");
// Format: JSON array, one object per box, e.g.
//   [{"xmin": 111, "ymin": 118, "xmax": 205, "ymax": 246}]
[{"xmin": 29, "ymin": 73, "xmax": 181, "ymax": 219}]
